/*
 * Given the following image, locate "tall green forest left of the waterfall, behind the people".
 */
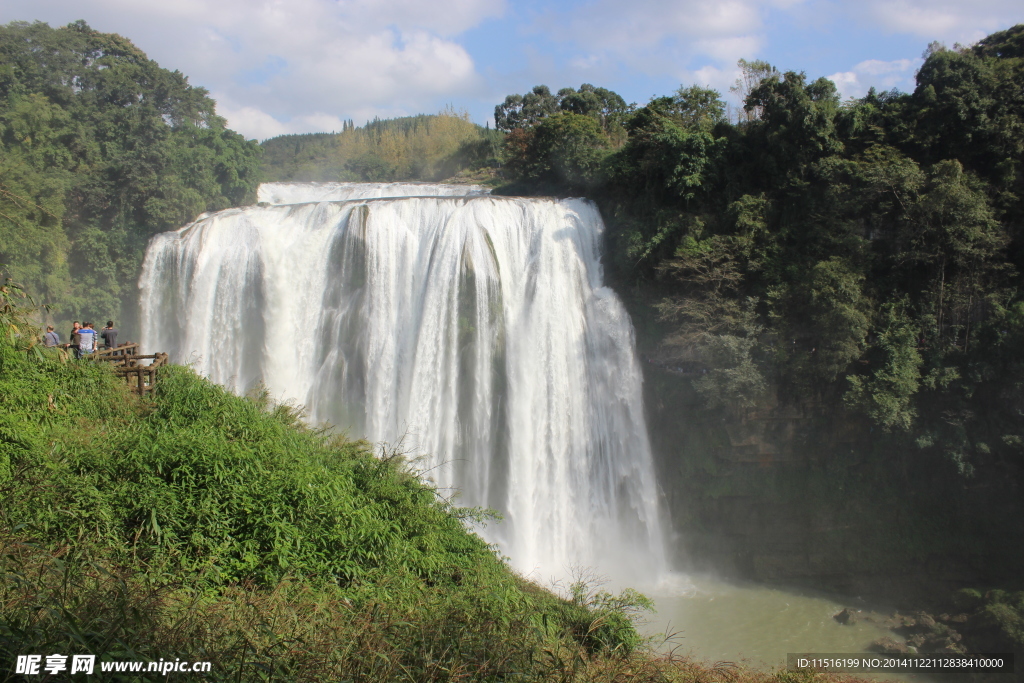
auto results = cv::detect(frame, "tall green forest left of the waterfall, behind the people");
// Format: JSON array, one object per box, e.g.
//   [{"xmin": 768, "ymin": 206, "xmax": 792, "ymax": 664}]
[{"xmin": 0, "ymin": 22, "xmax": 260, "ymax": 329}]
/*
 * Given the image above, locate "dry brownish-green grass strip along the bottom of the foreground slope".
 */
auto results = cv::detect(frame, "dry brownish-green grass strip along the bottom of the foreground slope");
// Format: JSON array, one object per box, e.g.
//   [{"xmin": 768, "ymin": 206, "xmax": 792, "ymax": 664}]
[{"xmin": 0, "ymin": 536, "xmax": 872, "ymax": 683}]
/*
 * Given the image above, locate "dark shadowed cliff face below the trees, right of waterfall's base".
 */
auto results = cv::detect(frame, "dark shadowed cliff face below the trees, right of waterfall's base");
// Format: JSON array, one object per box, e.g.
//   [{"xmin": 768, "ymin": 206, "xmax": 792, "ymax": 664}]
[{"xmin": 644, "ymin": 364, "xmax": 1022, "ymax": 601}]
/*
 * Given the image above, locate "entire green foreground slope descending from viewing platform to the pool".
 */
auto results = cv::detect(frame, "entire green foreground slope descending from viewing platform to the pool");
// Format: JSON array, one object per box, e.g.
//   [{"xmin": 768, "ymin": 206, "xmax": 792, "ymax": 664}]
[{"xmin": 0, "ymin": 294, "xmax": 872, "ymax": 681}]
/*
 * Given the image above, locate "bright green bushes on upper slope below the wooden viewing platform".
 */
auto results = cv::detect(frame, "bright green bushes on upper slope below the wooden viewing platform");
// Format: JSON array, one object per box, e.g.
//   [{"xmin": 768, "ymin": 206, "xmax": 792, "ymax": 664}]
[{"xmin": 0, "ymin": 349, "xmax": 509, "ymax": 588}]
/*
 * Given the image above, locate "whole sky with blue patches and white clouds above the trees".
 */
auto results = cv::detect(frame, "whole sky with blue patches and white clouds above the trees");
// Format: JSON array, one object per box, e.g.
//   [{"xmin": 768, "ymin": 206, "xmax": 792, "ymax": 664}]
[{"xmin": 0, "ymin": 0, "xmax": 1024, "ymax": 139}]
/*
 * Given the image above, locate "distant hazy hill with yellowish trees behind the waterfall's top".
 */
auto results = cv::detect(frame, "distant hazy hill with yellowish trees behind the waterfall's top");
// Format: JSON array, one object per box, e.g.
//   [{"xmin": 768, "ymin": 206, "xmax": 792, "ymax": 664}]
[{"xmin": 262, "ymin": 110, "xmax": 501, "ymax": 181}]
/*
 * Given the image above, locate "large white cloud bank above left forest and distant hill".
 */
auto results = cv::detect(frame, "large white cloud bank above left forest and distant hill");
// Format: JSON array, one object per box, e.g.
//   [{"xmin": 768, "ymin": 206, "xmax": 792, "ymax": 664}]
[{"xmin": 0, "ymin": 0, "xmax": 505, "ymax": 137}]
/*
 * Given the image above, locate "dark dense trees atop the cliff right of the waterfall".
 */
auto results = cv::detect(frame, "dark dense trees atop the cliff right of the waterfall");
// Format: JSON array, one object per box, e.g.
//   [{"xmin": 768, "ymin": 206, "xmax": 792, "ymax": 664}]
[{"xmin": 496, "ymin": 26, "xmax": 1024, "ymax": 491}]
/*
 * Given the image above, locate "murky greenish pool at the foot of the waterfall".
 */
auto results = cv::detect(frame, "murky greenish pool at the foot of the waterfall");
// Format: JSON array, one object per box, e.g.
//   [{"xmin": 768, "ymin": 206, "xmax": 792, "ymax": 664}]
[{"xmin": 643, "ymin": 575, "xmax": 931, "ymax": 683}]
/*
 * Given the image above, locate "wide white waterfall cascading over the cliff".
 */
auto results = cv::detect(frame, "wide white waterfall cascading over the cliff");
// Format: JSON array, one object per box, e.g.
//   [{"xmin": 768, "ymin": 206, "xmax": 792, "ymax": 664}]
[{"xmin": 139, "ymin": 183, "xmax": 665, "ymax": 582}]
